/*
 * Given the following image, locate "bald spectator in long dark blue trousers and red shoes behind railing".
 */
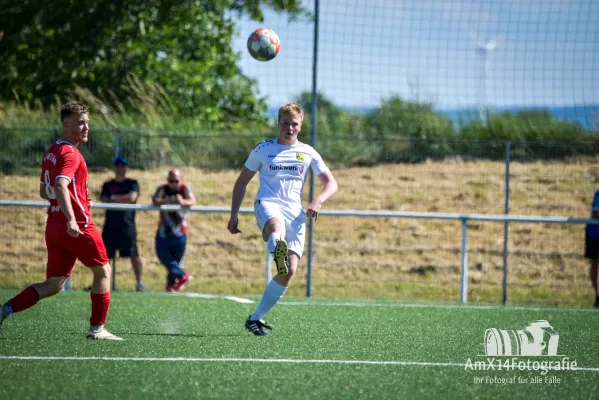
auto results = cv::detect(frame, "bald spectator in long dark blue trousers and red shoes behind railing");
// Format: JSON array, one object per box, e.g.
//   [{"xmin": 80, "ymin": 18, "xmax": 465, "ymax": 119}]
[{"xmin": 152, "ymin": 169, "xmax": 196, "ymax": 292}]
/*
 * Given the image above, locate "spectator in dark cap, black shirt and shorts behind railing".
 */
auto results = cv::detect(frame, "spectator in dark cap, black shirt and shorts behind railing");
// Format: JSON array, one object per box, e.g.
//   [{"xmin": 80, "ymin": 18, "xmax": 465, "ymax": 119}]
[{"xmin": 100, "ymin": 156, "xmax": 144, "ymax": 292}]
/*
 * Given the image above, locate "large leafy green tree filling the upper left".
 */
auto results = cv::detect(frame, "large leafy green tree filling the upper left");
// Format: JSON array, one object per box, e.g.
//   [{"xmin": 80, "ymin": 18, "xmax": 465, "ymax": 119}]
[{"xmin": 0, "ymin": 0, "xmax": 306, "ymax": 123}]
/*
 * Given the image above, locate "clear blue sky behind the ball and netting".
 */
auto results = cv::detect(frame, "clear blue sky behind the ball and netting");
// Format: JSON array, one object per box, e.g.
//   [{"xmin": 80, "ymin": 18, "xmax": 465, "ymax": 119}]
[{"xmin": 233, "ymin": 0, "xmax": 599, "ymax": 108}]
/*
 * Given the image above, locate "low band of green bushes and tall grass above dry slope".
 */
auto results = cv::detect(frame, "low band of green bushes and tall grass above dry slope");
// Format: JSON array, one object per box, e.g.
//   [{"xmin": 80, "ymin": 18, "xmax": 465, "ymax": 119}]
[{"xmin": 0, "ymin": 91, "xmax": 599, "ymax": 174}]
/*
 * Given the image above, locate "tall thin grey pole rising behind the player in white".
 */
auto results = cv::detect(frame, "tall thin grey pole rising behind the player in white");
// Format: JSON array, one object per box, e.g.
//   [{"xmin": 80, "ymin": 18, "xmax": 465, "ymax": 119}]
[{"xmin": 306, "ymin": 0, "xmax": 318, "ymax": 297}]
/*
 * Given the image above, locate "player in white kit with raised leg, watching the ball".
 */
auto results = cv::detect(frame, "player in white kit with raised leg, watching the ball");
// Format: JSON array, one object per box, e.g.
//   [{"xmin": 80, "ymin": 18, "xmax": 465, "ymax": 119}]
[{"xmin": 227, "ymin": 103, "xmax": 337, "ymax": 336}]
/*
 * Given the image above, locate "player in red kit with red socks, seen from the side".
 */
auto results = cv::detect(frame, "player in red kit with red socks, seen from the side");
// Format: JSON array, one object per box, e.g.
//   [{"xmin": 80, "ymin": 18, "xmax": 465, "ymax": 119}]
[{"xmin": 0, "ymin": 101, "xmax": 123, "ymax": 340}]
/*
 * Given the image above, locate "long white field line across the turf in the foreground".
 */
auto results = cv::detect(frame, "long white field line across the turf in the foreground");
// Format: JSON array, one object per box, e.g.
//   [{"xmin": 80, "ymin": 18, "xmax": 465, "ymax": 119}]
[{"xmin": 0, "ymin": 356, "xmax": 599, "ymax": 372}]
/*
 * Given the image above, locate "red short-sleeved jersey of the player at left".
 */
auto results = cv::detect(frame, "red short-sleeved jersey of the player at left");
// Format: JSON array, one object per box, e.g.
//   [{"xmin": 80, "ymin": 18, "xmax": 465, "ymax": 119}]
[{"xmin": 40, "ymin": 140, "xmax": 91, "ymax": 227}]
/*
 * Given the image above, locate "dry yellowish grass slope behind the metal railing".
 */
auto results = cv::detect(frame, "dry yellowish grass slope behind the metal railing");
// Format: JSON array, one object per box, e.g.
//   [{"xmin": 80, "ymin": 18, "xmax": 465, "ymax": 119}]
[{"xmin": 0, "ymin": 160, "xmax": 599, "ymax": 304}]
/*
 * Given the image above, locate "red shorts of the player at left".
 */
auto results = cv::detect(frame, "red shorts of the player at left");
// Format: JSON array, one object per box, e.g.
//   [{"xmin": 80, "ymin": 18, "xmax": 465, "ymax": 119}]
[{"xmin": 46, "ymin": 222, "xmax": 108, "ymax": 278}]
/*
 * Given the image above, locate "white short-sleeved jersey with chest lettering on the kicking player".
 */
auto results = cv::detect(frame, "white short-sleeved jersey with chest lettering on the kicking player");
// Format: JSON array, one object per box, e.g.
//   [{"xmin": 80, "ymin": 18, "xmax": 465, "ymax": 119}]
[{"xmin": 245, "ymin": 138, "xmax": 329, "ymax": 210}]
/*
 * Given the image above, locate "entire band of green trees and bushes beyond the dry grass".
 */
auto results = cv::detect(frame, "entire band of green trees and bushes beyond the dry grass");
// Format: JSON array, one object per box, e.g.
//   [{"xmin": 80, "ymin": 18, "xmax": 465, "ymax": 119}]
[{"xmin": 0, "ymin": 0, "xmax": 599, "ymax": 173}]
